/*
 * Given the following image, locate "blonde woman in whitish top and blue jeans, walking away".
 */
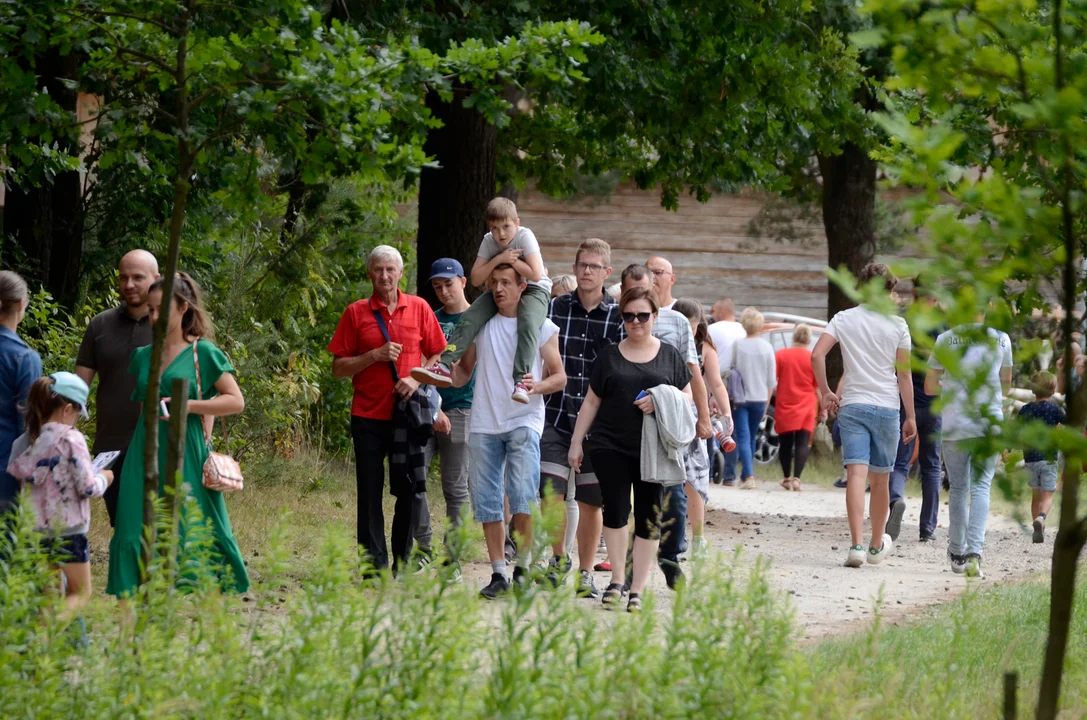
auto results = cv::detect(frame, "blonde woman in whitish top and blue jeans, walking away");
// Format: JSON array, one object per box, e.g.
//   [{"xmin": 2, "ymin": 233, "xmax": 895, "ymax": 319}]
[{"xmin": 733, "ymin": 308, "xmax": 777, "ymax": 491}]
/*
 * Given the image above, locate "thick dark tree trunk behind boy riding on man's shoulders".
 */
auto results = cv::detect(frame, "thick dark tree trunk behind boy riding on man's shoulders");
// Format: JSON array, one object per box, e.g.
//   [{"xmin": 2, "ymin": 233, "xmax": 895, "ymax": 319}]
[{"xmin": 416, "ymin": 88, "xmax": 498, "ymax": 305}]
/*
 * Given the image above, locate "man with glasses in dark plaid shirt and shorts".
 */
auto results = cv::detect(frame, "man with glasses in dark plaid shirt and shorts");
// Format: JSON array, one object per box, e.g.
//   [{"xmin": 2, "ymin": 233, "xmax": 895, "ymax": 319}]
[{"xmin": 540, "ymin": 238, "xmax": 623, "ymax": 598}]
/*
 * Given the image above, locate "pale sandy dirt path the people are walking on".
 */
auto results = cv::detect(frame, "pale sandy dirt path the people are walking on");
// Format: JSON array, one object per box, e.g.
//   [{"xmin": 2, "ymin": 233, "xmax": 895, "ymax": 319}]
[{"xmin": 465, "ymin": 482, "xmax": 1052, "ymax": 638}]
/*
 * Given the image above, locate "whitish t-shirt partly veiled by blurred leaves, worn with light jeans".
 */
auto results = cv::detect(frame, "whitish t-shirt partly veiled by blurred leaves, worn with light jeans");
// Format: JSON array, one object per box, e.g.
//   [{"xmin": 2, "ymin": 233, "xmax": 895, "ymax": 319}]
[{"xmin": 928, "ymin": 325, "xmax": 1012, "ymax": 440}]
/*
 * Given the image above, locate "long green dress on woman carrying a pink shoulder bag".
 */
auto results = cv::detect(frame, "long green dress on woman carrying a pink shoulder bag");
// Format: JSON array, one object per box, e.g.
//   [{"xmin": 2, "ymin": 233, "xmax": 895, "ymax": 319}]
[{"xmin": 105, "ymin": 339, "xmax": 249, "ymax": 597}]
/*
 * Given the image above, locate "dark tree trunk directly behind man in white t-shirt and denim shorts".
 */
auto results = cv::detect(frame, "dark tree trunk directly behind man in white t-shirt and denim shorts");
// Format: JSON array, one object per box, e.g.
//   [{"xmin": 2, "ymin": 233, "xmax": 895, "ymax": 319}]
[{"xmin": 819, "ymin": 142, "xmax": 876, "ymax": 389}]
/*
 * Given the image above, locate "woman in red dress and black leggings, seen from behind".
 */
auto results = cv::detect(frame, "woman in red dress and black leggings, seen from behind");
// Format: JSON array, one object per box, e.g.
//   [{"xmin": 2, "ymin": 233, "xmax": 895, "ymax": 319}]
[{"xmin": 774, "ymin": 323, "xmax": 820, "ymax": 492}]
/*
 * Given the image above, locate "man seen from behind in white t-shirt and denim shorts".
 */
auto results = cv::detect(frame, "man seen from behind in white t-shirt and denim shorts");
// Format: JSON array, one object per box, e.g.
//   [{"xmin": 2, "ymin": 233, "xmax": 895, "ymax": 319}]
[{"xmin": 812, "ymin": 263, "xmax": 917, "ymax": 568}]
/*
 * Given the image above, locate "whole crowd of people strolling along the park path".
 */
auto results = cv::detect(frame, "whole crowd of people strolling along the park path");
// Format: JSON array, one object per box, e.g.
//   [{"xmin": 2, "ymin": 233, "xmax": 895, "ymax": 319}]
[{"xmin": 0, "ymin": 198, "xmax": 1065, "ymax": 611}]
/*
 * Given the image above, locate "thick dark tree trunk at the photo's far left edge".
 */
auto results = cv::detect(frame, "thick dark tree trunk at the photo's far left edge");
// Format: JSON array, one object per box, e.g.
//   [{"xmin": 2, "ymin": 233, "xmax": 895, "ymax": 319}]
[{"xmin": 3, "ymin": 49, "xmax": 84, "ymax": 308}]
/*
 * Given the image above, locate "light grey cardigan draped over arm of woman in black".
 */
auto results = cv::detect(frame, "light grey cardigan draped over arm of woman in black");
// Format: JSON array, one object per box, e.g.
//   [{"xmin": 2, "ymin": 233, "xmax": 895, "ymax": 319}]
[{"xmin": 641, "ymin": 385, "xmax": 696, "ymax": 486}]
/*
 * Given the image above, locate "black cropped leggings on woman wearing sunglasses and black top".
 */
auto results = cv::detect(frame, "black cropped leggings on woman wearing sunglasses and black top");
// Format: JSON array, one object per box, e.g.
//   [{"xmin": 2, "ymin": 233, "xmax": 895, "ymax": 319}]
[{"xmin": 592, "ymin": 450, "xmax": 664, "ymax": 539}]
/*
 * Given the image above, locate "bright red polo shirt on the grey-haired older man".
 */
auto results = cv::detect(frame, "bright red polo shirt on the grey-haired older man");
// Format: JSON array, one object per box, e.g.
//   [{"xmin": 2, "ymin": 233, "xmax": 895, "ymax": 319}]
[{"xmin": 328, "ymin": 290, "xmax": 446, "ymax": 420}]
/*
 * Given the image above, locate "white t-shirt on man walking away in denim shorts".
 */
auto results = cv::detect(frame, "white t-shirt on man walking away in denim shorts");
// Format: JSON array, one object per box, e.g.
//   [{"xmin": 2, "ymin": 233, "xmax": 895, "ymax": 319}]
[{"xmin": 823, "ymin": 306, "xmax": 911, "ymax": 410}]
